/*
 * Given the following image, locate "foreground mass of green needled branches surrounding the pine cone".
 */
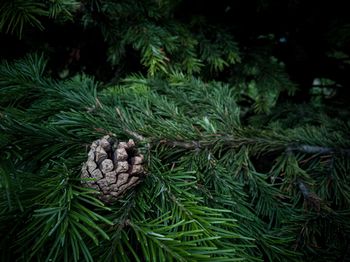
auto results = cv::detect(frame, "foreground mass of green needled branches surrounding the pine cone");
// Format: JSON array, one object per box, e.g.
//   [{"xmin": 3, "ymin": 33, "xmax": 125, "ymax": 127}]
[{"xmin": 0, "ymin": 52, "xmax": 350, "ymax": 261}]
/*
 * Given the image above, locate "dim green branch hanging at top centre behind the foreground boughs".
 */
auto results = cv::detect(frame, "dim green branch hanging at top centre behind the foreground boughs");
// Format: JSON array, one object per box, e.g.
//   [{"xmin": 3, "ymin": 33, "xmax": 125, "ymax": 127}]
[{"xmin": 83, "ymin": 1, "xmax": 240, "ymax": 76}]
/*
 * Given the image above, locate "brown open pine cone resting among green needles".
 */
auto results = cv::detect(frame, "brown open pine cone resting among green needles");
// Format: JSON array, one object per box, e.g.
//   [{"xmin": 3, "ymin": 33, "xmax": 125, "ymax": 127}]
[{"xmin": 81, "ymin": 136, "xmax": 145, "ymax": 203}]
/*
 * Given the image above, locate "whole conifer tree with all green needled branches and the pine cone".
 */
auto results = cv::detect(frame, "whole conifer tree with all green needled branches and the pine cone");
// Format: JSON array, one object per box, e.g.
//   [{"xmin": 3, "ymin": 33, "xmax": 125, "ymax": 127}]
[{"xmin": 0, "ymin": 0, "xmax": 350, "ymax": 262}]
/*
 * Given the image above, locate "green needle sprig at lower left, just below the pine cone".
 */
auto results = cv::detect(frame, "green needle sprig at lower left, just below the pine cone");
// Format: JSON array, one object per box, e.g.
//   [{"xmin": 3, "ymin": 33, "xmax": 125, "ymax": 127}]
[{"xmin": 16, "ymin": 166, "xmax": 113, "ymax": 261}]
